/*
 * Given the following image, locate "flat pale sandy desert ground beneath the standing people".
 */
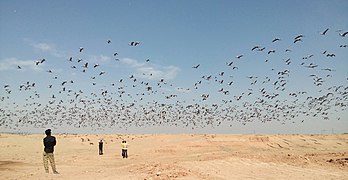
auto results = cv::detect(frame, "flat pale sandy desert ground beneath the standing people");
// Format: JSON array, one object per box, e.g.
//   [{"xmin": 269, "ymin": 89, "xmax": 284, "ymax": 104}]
[{"xmin": 0, "ymin": 134, "xmax": 348, "ymax": 180}]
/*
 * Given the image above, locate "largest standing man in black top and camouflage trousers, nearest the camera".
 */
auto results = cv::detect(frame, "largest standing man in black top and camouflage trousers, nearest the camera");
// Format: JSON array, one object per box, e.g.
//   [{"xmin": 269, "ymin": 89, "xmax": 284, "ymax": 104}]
[{"xmin": 43, "ymin": 129, "xmax": 59, "ymax": 174}]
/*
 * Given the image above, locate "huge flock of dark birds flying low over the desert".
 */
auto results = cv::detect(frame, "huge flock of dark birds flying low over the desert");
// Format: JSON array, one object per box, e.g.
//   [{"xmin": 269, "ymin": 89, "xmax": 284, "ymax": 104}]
[{"xmin": 0, "ymin": 28, "xmax": 348, "ymax": 130}]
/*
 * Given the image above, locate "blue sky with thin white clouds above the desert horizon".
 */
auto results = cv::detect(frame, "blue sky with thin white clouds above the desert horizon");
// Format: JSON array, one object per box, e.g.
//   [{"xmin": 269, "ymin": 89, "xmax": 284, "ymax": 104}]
[{"xmin": 0, "ymin": 0, "xmax": 348, "ymax": 134}]
